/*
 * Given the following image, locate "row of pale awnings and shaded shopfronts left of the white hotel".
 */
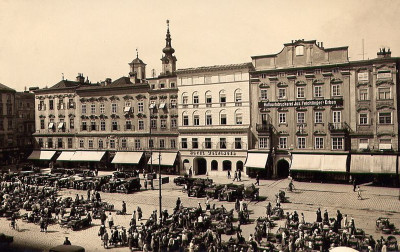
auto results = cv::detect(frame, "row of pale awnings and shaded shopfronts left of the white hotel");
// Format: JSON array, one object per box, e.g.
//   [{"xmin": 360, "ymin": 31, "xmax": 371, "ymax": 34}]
[{"xmin": 28, "ymin": 150, "xmax": 179, "ymax": 174}]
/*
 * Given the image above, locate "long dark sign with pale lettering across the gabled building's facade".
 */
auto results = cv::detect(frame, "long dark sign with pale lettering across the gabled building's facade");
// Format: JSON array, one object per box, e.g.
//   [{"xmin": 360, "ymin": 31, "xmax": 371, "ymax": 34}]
[{"xmin": 258, "ymin": 99, "xmax": 343, "ymax": 108}]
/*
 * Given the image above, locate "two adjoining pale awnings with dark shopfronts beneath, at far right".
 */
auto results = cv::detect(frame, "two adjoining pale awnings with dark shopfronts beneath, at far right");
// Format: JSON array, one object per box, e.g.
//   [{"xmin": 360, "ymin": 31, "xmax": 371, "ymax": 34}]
[{"xmin": 290, "ymin": 154, "xmax": 400, "ymax": 185}]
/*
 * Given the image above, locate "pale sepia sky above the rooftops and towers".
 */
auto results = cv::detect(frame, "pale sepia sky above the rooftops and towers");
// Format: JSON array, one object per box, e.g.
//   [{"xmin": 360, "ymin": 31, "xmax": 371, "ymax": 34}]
[{"xmin": 0, "ymin": 0, "xmax": 400, "ymax": 91}]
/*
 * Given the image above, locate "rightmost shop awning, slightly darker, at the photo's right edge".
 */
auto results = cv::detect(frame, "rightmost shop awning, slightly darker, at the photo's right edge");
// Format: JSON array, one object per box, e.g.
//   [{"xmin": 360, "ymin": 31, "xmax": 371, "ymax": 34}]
[{"xmin": 350, "ymin": 155, "xmax": 397, "ymax": 174}]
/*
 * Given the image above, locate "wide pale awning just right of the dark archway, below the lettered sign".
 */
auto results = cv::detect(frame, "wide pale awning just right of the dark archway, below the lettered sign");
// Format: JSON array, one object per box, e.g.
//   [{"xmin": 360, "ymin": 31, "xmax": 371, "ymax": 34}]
[{"xmin": 290, "ymin": 154, "xmax": 347, "ymax": 172}]
